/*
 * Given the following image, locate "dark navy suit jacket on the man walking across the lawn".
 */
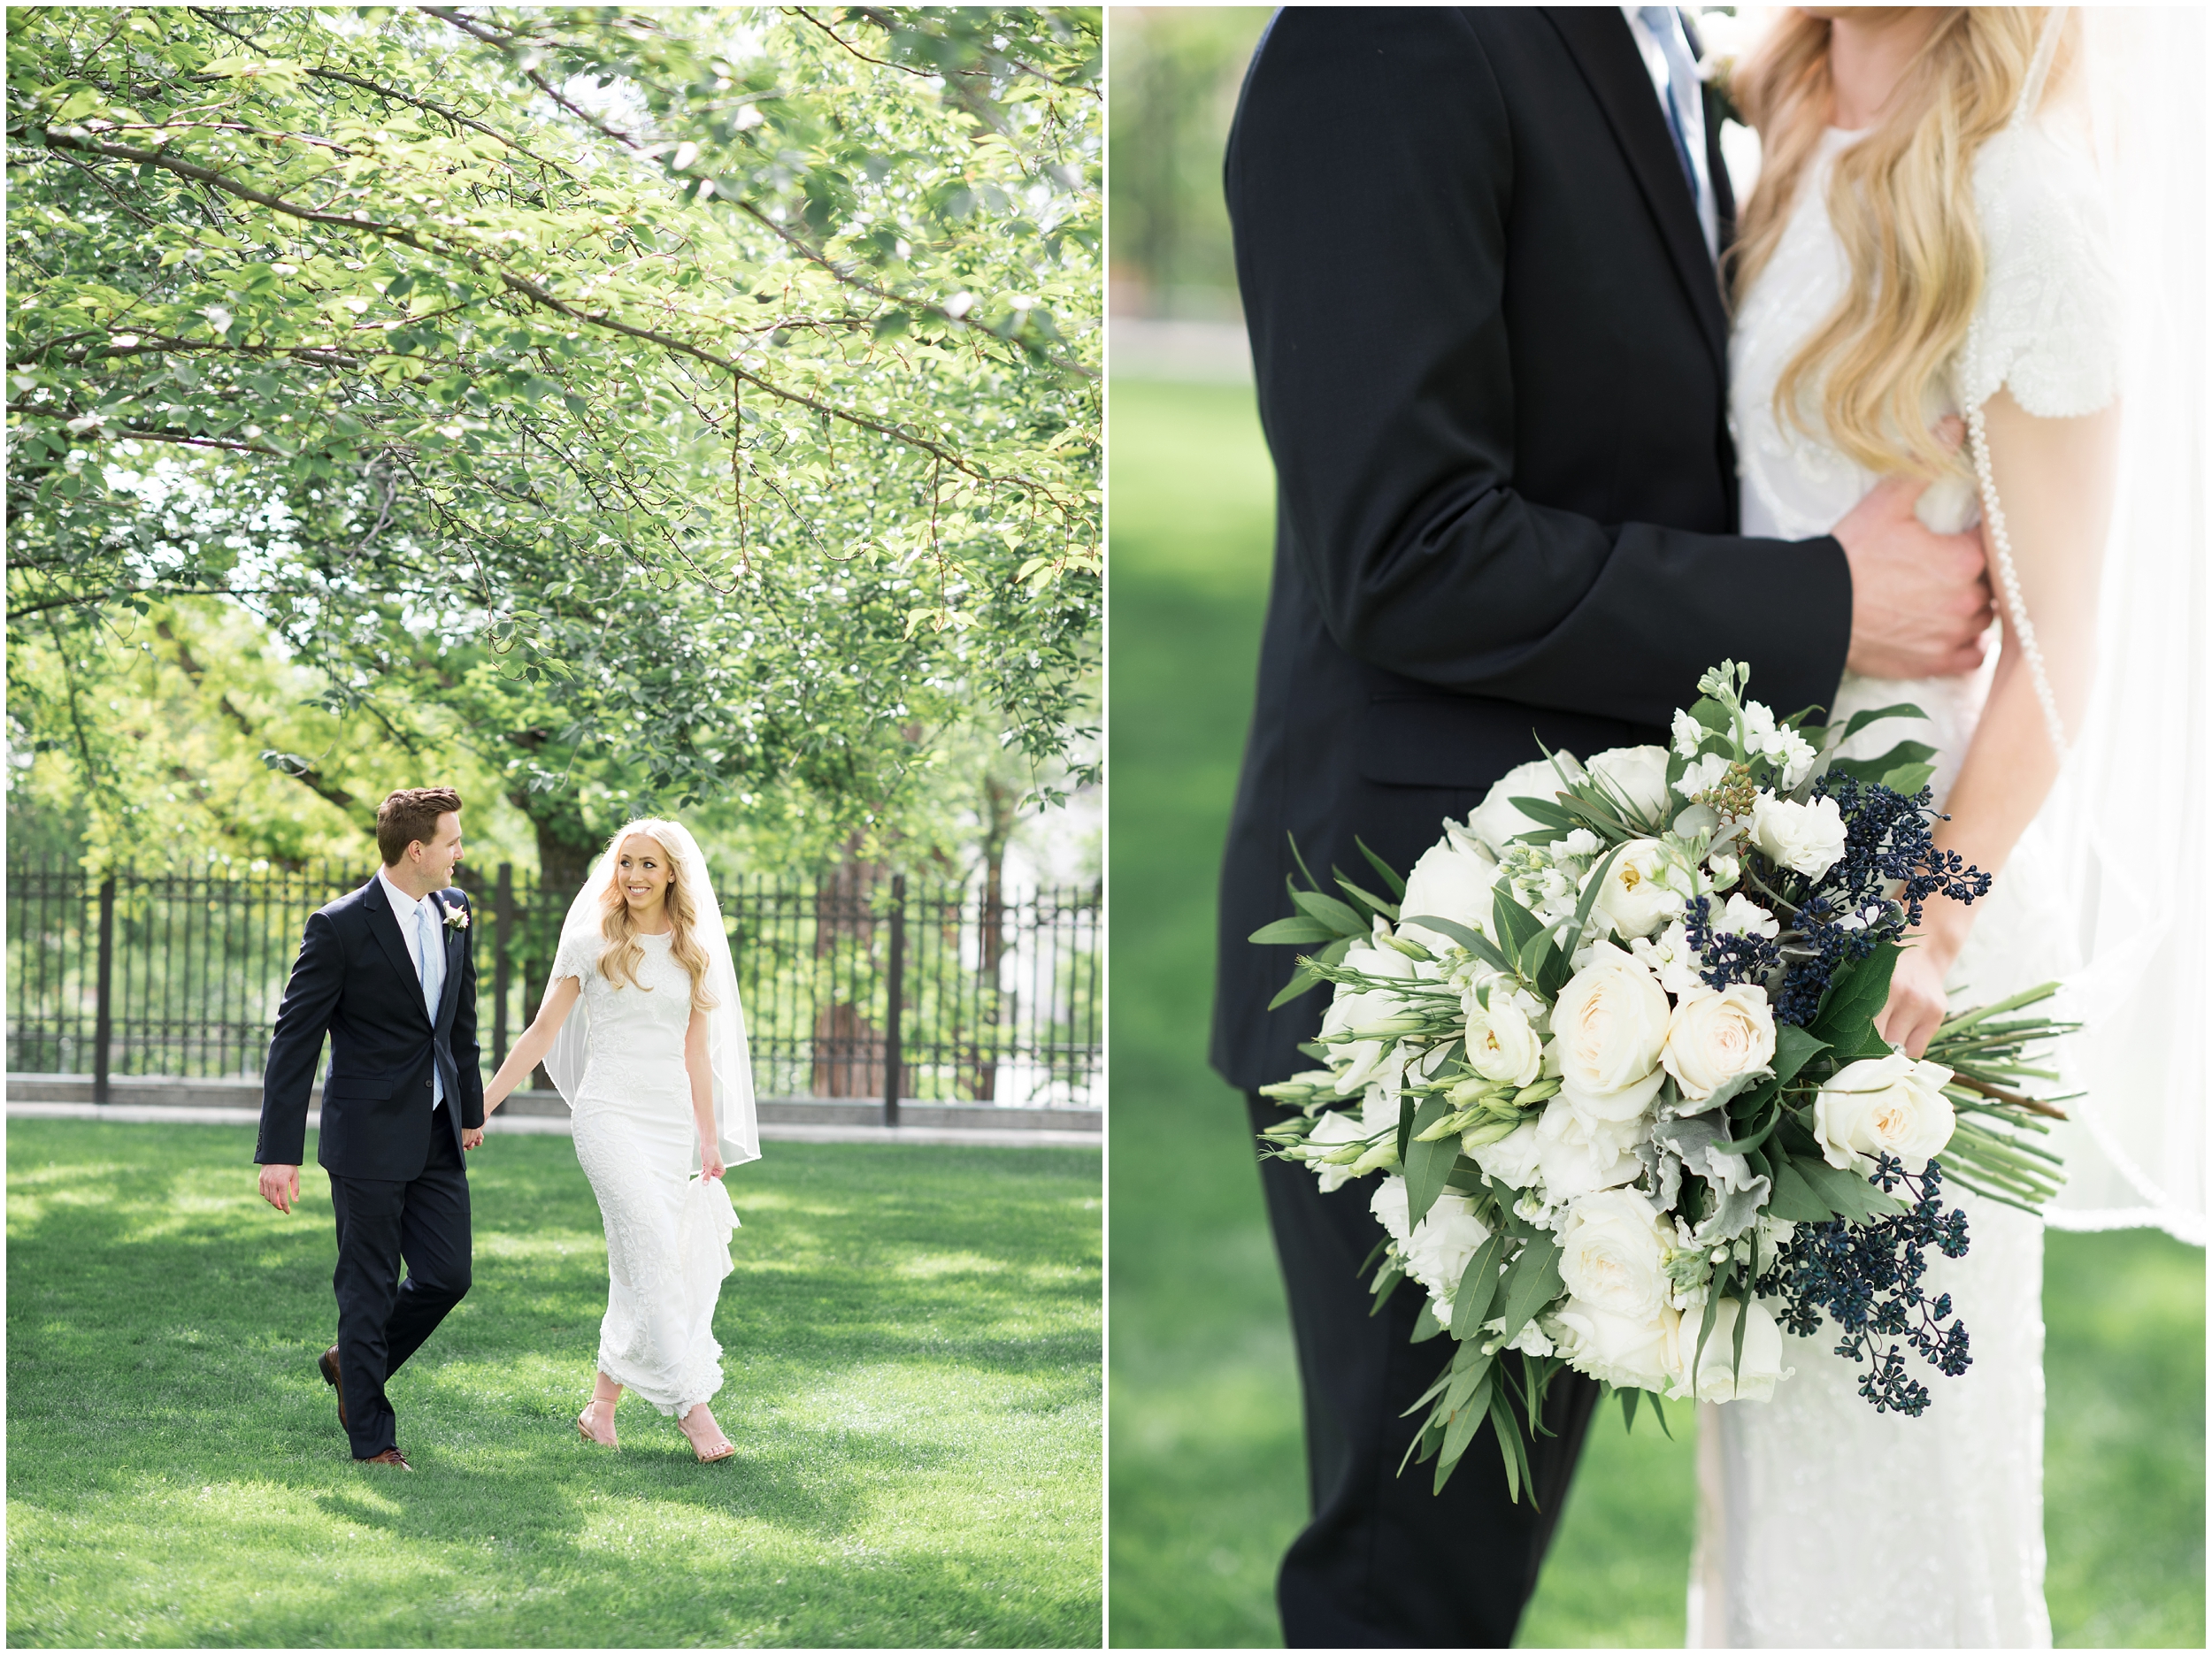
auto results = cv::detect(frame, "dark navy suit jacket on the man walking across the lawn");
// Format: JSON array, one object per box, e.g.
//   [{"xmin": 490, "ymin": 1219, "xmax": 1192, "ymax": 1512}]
[{"xmin": 255, "ymin": 878, "xmax": 485, "ymax": 1182}]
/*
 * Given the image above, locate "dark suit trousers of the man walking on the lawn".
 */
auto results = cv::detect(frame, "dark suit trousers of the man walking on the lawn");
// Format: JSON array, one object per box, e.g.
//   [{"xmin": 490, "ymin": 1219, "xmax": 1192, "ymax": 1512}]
[{"xmin": 330, "ymin": 1104, "xmax": 472, "ymax": 1460}]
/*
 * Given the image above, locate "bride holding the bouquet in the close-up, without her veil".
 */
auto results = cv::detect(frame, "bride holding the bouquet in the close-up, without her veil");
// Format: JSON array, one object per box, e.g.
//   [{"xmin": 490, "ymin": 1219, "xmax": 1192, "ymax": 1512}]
[{"xmin": 1690, "ymin": 7, "xmax": 2119, "ymax": 1646}]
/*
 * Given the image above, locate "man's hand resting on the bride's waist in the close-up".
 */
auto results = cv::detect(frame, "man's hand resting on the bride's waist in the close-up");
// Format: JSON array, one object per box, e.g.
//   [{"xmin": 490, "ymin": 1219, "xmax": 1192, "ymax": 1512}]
[{"xmin": 1836, "ymin": 464, "xmax": 1995, "ymax": 679}]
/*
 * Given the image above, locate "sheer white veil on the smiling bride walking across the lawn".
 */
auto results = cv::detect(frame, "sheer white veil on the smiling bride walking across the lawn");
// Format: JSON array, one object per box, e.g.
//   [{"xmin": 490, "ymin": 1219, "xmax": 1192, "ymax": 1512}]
[{"xmin": 547, "ymin": 816, "xmax": 761, "ymax": 1166}]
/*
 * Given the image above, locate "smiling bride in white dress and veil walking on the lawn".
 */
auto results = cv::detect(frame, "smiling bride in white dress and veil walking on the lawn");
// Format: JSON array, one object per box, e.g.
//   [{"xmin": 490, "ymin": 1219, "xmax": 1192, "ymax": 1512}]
[{"xmin": 485, "ymin": 818, "xmax": 761, "ymax": 1460}]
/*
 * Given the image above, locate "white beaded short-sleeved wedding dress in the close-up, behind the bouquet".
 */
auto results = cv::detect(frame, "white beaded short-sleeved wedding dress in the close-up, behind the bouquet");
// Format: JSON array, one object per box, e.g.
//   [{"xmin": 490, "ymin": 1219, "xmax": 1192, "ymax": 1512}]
[{"xmin": 1690, "ymin": 113, "xmax": 2119, "ymax": 1648}]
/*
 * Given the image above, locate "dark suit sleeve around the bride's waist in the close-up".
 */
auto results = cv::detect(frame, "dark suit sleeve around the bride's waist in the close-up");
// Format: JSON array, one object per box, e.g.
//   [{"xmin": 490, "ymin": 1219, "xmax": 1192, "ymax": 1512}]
[{"xmin": 1225, "ymin": 7, "xmax": 1852, "ymax": 725}]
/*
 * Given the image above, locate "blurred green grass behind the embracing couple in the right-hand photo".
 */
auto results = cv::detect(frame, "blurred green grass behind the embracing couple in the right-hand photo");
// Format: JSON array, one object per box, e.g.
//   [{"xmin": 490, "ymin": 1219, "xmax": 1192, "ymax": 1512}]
[{"xmin": 1109, "ymin": 369, "xmax": 2206, "ymax": 1648}]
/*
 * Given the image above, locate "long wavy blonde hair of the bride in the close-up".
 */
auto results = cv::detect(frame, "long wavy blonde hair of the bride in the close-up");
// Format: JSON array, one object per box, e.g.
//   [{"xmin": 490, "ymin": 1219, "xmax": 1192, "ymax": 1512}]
[{"xmin": 1728, "ymin": 7, "xmax": 2082, "ymax": 478}]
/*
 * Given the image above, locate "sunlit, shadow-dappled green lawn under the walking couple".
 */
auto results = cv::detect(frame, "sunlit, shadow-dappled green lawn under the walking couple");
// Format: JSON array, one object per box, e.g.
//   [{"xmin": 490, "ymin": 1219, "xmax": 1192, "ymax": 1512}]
[{"xmin": 7, "ymin": 1120, "xmax": 1100, "ymax": 1646}]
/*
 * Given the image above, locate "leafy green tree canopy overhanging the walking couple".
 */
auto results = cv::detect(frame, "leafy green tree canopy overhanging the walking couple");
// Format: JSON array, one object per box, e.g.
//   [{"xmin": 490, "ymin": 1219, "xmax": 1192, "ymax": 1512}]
[{"xmin": 7, "ymin": 7, "xmax": 1100, "ymax": 881}]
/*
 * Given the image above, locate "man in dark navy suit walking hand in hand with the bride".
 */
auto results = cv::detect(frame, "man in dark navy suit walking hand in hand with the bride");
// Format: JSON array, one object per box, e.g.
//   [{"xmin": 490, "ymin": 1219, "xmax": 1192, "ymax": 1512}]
[{"xmin": 255, "ymin": 787, "xmax": 485, "ymax": 1471}]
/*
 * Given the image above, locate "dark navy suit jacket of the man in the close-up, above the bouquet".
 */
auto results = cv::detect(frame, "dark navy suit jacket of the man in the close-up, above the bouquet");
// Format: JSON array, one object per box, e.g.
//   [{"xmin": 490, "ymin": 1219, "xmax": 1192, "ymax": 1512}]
[{"xmin": 1212, "ymin": 7, "xmax": 1852, "ymax": 1089}]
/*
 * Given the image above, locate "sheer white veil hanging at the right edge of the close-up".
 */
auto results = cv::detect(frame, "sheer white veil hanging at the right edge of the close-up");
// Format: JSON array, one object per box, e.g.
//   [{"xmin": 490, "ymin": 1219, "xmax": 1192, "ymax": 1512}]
[{"xmin": 2039, "ymin": 7, "xmax": 2212, "ymax": 1245}]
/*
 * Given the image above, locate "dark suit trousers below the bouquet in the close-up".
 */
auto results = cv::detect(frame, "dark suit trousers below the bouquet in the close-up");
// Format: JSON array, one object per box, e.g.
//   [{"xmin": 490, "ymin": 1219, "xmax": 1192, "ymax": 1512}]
[{"xmin": 1248, "ymin": 1093, "xmax": 1597, "ymax": 1648}]
